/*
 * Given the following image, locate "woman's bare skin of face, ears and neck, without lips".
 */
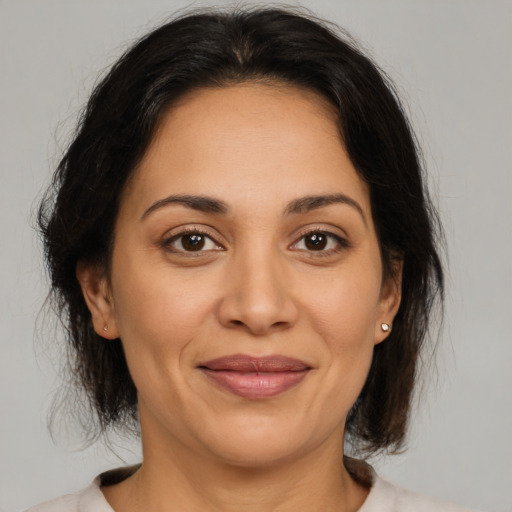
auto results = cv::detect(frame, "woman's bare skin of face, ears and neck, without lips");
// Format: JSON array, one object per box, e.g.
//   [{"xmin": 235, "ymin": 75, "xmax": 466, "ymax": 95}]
[{"xmin": 77, "ymin": 83, "xmax": 400, "ymax": 512}]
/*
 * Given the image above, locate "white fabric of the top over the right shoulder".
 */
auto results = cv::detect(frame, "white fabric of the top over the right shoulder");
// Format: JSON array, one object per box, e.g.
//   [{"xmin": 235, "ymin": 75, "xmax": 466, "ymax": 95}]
[{"xmin": 359, "ymin": 476, "xmax": 478, "ymax": 512}]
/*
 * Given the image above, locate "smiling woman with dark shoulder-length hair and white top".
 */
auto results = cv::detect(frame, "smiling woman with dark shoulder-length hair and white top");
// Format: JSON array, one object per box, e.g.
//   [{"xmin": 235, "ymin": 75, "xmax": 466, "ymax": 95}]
[{"xmin": 32, "ymin": 10, "xmax": 472, "ymax": 512}]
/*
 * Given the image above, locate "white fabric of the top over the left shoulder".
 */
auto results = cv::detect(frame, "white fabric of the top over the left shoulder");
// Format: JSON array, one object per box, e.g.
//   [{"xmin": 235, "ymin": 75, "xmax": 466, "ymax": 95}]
[{"xmin": 25, "ymin": 479, "xmax": 114, "ymax": 512}]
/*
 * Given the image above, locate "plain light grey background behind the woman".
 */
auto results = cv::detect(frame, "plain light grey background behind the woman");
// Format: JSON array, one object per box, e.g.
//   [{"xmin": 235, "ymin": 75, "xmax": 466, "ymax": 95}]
[{"xmin": 0, "ymin": 0, "xmax": 512, "ymax": 512}]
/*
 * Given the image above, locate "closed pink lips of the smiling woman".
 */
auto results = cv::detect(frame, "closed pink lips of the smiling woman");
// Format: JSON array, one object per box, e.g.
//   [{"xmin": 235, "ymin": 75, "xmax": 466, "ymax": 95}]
[{"xmin": 199, "ymin": 354, "xmax": 311, "ymax": 399}]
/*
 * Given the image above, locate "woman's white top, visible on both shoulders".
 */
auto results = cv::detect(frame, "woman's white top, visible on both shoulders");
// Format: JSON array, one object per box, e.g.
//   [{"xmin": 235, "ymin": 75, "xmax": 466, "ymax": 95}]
[{"xmin": 26, "ymin": 473, "xmax": 476, "ymax": 512}]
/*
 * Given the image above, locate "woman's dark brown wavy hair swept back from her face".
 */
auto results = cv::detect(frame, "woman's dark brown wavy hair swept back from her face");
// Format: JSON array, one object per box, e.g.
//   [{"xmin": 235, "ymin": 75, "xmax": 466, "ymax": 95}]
[{"xmin": 39, "ymin": 9, "xmax": 443, "ymax": 452}]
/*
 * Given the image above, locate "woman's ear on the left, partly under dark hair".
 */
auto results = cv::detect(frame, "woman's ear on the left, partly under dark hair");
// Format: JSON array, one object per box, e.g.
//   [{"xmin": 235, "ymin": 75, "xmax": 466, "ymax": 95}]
[{"xmin": 76, "ymin": 261, "xmax": 119, "ymax": 340}]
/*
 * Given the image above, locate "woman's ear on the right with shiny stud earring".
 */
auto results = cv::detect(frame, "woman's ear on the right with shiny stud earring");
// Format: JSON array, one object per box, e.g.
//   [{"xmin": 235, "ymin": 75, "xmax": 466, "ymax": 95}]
[{"xmin": 375, "ymin": 258, "xmax": 404, "ymax": 344}]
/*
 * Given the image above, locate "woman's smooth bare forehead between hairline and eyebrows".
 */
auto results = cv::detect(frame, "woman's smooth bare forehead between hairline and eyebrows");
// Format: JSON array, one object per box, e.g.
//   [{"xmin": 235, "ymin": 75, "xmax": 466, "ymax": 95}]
[{"xmin": 121, "ymin": 83, "xmax": 369, "ymax": 218}]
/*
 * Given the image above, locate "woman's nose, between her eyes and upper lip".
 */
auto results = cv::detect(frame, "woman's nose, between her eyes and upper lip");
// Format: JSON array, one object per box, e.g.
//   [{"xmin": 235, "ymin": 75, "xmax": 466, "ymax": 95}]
[{"xmin": 218, "ymin": 249, "xmax": 298, "ymax": 336}]
